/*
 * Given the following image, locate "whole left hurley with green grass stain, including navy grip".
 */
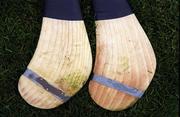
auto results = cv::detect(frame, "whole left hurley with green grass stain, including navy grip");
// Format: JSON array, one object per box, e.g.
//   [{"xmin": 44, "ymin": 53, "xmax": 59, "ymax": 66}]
[{"xmin": 18, "ymin": 0, "xmax": 92, "ymax": 109}]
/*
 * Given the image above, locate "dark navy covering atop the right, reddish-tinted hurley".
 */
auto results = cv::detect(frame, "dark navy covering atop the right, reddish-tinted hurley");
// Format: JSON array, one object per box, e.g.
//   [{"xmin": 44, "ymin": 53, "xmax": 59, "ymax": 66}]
[{"xmin": 92, "ymin": 0, "xmax": 132, "ymax": 20}]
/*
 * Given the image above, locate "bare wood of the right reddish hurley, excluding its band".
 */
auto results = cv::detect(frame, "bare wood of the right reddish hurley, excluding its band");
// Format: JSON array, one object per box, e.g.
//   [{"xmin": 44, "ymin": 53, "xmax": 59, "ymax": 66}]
[{"xmin": 89, "ymin": 14, "xmax": 156, "ymax": 111}]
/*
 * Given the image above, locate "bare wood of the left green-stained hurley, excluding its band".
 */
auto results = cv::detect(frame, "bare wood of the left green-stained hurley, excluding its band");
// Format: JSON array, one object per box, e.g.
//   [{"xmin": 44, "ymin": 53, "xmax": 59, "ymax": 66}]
[{"xmin": 18, "ymin": 17, "xmax": 92, "ymax": 109}]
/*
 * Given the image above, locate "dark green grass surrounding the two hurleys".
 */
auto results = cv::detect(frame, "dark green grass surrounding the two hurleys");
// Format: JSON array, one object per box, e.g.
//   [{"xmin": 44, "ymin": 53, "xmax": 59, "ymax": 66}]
[{"xmin": 0, "ymin": 0, "xmax": 179, "ymax": 117}]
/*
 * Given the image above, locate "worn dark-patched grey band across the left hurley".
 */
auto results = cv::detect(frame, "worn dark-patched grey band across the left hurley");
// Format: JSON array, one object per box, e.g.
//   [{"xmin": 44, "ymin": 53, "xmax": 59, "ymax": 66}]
[{"xmin": 23, "ymin": 69, "xmax": 70, "ymax": 102}]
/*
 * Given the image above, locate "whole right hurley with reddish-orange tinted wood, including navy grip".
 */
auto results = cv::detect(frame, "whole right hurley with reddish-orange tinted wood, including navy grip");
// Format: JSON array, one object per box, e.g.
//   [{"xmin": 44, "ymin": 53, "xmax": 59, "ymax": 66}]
[{"xmin": 89, "ymin": 0, "xmax": 156, "ymax": 111}]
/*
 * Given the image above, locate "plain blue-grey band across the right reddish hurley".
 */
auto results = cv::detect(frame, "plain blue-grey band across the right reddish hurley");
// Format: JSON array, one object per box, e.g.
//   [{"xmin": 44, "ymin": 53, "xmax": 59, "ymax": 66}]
[{"xmin": 92, "ymin": 75, "xmax": 144, "ymax": 98}]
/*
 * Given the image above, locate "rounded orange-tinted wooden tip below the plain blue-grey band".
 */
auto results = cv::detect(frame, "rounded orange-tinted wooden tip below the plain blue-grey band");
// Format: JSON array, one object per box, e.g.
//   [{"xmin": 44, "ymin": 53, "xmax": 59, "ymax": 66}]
[{"xmin": 89, "ymin": 81, "xmax": 137, "ymax": 111}]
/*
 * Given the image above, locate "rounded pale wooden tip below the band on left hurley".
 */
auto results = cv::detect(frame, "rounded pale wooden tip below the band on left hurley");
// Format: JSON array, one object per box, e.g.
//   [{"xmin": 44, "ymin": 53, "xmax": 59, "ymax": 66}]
[{"xmin": 18, "ymin": 76, "xmax": 63, "ymax": 109}]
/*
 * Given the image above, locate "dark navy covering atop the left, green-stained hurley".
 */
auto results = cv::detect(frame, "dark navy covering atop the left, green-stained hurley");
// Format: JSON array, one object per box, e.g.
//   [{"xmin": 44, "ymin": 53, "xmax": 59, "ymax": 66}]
[{"xmin": 44, "ymin": 0, "xmax": 82, "ymax": 20}]
